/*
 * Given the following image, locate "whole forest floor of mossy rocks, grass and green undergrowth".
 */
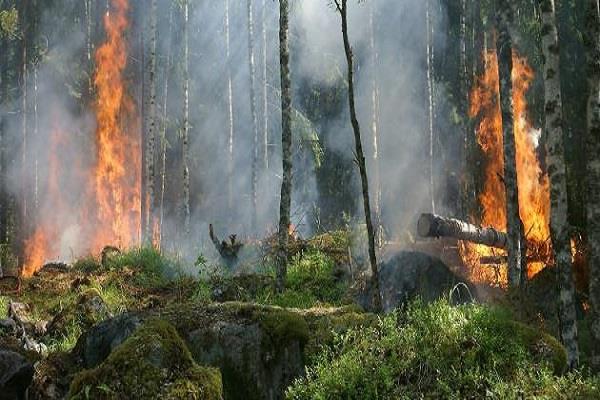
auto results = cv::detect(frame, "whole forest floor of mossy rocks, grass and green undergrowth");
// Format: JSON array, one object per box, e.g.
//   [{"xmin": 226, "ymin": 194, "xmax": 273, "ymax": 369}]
[{"xmin": 0, "ymin": 231, "xmax": 600, "ymax": 399}]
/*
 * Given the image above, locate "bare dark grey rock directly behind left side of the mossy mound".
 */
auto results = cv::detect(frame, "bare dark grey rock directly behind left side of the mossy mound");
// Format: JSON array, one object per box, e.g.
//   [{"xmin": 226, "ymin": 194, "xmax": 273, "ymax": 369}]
[{"xmin": 75, "ymin": 314, "xmax": 142, "ymax": 368}]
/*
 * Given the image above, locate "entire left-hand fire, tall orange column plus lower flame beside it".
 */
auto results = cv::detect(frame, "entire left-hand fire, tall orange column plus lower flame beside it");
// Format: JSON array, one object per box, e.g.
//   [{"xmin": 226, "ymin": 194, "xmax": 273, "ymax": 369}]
[{"xmin": 22, "ymin": 0, "xmax": 141, "ymax": 276}]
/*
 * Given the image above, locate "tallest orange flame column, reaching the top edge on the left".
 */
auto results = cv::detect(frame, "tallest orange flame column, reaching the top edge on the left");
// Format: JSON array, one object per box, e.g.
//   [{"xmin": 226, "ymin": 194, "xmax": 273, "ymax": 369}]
[{"xmin": 92, "ymin": 0, "xmax": 141, "ymax": 249}]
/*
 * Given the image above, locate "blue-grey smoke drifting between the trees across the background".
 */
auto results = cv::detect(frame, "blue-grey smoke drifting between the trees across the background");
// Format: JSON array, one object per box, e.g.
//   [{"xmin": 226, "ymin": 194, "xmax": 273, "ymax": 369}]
[{"xmin": 4, "ymin": 0, "xmax": 454, "ymax": 268}]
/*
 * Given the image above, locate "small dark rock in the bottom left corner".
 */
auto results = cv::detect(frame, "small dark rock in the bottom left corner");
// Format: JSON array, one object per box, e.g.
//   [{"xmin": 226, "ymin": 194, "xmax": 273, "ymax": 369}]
[{"xmin": 0, "ymin": 350, "xmax": 34, "ymax": 400}]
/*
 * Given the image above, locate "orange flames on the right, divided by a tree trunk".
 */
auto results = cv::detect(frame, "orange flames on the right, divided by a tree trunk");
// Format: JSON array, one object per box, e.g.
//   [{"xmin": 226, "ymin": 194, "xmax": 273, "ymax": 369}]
[{"xmin": 461, "ymin": 52, "xmax": 551, "ymax": 286}]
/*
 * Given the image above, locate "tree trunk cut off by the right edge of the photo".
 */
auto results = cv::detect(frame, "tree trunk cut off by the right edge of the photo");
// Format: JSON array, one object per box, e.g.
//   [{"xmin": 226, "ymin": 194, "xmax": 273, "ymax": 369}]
[{"xmin": 586, "ymin": 0, "xmax": 600, "ymax": 372}]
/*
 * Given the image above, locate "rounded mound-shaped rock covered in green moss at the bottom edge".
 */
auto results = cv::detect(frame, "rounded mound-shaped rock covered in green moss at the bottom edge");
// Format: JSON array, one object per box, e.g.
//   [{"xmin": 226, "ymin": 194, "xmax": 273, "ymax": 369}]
[{"xmin": 69, "ymin": 319, "xmax": 222, "ymax": 400}]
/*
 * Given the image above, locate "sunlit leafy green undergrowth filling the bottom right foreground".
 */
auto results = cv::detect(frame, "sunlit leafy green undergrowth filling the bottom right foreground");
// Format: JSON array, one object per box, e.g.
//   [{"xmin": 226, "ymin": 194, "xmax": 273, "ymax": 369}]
[{"xmin": 287, "ymin": 301, "xmax": 600, "ymax": 399}]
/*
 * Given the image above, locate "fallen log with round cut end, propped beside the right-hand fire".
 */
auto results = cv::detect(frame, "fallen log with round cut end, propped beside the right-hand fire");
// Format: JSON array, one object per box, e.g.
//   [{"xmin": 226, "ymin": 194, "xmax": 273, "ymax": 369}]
[{"xmin": 417, "ymin": 214, "xmax": 508, "ymax": 249}]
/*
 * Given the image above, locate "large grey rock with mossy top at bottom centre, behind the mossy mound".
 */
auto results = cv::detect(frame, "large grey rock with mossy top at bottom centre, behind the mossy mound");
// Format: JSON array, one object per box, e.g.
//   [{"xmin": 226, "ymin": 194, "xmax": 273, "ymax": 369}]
[{"xmin": 76, "ymin": 302, "xmax": 376, "ymax": 400}]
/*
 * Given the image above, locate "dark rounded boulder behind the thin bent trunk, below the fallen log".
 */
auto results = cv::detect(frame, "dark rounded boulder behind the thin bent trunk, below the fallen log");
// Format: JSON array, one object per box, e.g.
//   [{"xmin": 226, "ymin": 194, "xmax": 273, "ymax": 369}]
[{"xmin": 355, "ymin": 251, "xmax": 474, "ymax": 312}]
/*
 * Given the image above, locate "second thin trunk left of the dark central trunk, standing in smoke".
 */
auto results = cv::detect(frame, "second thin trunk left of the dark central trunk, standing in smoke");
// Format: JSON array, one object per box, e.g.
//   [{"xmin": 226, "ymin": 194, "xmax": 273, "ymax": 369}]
[{"xmin": 246, "ymin": 0, "xmax": 259, "ymax": 232}]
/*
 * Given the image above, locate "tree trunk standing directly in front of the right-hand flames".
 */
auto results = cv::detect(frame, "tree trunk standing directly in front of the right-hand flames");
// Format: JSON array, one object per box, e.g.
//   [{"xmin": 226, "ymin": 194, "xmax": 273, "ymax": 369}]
[{"xmin": 496, "ymin": 0, "xmax": 526, "ymax": 288}]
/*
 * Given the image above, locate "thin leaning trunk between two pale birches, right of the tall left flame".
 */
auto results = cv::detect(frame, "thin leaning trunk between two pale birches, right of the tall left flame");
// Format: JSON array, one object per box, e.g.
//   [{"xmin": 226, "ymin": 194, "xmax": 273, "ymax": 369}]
[{"xmin": 159, "ymin": 3, "xmax": 173, "ymax": 247}]
